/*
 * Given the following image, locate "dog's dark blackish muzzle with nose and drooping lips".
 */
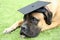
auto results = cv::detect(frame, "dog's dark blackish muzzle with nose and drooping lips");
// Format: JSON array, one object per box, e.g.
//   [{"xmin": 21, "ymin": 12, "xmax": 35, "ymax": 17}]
[{"xmin": 20, "ymin": 21, "xmax": 40, "ymax": 37}]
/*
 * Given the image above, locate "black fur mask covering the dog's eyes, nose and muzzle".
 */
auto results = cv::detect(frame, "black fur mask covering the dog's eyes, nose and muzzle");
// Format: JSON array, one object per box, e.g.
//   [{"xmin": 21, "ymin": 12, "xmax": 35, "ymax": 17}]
[{"xmin": 20, "ymin": 14, "xmax": 40, "ymax": 37}]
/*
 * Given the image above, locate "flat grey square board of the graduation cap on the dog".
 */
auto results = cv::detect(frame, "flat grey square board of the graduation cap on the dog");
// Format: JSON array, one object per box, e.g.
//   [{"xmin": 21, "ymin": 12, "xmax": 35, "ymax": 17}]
[{"xmin": 18, "ymin": 1, "xmax": 50, "ymax": 14}]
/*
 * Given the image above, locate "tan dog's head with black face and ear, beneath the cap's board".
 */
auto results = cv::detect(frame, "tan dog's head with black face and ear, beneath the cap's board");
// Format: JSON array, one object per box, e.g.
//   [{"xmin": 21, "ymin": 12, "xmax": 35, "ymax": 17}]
[{"xmin": 20, "ymin": 7, "xmax": 52, "ymax": 37}]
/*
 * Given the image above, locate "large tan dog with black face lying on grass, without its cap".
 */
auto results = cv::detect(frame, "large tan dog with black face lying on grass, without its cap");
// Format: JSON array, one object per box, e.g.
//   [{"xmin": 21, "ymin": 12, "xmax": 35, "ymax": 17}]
[{"xmin": 3, "ymin": 0, "xmax": 60, "ymax": 37}]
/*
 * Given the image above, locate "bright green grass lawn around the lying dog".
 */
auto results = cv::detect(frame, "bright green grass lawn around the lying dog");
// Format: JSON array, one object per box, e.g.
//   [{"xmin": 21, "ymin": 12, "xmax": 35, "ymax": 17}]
[{"xmin": 0, "ymin": 0, "xmax": 60, "ymax": 40}]
